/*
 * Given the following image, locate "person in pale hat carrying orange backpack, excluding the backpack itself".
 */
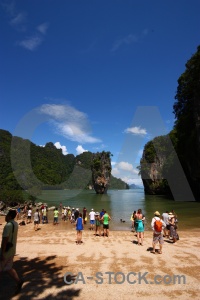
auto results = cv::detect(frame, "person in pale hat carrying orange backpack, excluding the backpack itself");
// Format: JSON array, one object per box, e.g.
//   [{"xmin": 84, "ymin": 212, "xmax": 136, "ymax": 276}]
[{"xmin": 151, "ymin": 211, "xmax": 166, "ymax": 254}]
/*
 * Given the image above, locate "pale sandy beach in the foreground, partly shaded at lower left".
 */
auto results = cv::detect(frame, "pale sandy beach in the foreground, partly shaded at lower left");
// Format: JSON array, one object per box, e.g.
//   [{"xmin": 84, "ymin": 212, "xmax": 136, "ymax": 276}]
[{"xmin": 0, "ymin": 217, "xmax": 200, "ymax": 300}]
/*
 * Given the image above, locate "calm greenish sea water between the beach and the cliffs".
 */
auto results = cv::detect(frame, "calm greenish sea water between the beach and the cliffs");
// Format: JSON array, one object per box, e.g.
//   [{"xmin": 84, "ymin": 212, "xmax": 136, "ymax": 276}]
[{"xmin": 37, "ymin": 189, "xmax": 200, "ymax": 230}]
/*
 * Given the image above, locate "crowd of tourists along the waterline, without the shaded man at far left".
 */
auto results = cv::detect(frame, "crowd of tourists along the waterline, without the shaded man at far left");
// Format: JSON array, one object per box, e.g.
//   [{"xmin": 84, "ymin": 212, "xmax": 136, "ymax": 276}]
[{"xmin": 3, "ymin": 203, "xmax": 179, "ymax": 254}]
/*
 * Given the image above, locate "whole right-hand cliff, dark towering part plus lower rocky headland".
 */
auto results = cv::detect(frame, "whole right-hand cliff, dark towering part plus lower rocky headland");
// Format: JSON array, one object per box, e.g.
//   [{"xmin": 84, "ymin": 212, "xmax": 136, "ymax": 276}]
[{"xmin": 139, "ymin": 46, "xmax": 200, "ymax": 200}]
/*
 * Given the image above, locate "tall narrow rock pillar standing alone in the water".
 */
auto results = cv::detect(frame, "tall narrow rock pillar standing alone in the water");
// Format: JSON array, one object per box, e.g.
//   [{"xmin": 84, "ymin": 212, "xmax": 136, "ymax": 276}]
[{"xmin": 91, "ymin": 151, "xmax": 111, "ymax": 194}]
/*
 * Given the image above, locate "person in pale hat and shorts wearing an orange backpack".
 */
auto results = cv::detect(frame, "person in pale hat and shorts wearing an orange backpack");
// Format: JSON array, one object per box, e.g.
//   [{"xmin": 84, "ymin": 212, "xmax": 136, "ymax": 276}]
[{"xmin": 151, "ymin": 211, "xmax": 166, "ymax": 254}]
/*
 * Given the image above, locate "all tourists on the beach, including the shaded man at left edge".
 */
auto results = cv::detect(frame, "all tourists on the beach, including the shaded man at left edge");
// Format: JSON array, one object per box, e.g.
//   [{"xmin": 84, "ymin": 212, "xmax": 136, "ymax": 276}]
[{"xmin": 0, "ymin": 204, "xmax": 179, "ymax": 294}]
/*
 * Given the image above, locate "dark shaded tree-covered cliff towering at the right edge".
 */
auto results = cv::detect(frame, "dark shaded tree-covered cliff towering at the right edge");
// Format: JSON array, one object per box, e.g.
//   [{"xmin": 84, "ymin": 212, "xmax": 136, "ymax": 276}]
[{"xmin": 173, "ymin": 46, "xmax": 200, "ymax": 196}]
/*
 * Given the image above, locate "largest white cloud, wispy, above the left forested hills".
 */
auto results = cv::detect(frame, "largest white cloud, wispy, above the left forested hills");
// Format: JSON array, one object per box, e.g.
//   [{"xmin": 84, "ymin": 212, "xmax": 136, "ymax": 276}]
[{"xmin": 39, "ymin": 104, "xmax": 101, "ymax": 144}]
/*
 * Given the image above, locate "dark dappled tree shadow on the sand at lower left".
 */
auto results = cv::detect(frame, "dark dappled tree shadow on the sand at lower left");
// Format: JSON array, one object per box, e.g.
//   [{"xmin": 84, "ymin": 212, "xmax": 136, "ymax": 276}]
[{"xmin": 0, "ymin": 256, "xmax": 81, "ymax": 300}]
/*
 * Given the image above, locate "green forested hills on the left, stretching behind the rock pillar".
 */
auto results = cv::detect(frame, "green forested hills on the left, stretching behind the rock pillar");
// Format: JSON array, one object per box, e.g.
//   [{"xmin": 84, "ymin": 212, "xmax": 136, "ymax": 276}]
[{"xmin": 0, "ymin": 130, "xmax": 127, "ymax": 200}]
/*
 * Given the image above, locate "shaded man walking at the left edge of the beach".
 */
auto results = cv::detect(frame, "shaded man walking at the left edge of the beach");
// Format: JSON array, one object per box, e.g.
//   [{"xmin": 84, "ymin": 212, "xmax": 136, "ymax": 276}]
[{"xmin": 0, "ymin": 210, "xmax": 24, "ymax": 295}]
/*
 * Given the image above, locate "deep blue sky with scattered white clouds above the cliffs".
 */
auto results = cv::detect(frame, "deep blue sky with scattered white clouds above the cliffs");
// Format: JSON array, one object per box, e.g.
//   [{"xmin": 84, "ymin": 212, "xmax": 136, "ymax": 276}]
[{"xmin": 0, "ymin": 0, "xmax": 200, "ymax": 184}]
